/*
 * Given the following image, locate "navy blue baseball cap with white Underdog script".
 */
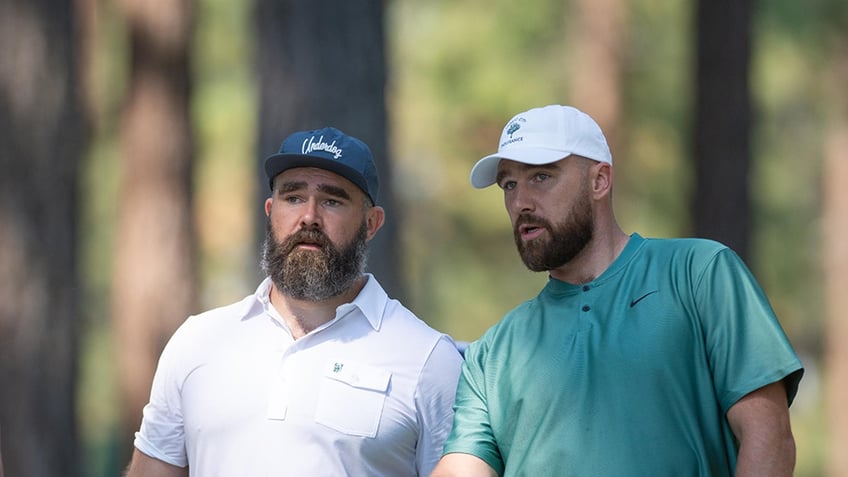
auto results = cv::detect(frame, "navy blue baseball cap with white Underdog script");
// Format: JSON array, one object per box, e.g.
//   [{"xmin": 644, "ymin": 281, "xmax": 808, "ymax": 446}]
[{"xmin": 265, "ymin": 127, "xmax": 379, "ymax": 204}]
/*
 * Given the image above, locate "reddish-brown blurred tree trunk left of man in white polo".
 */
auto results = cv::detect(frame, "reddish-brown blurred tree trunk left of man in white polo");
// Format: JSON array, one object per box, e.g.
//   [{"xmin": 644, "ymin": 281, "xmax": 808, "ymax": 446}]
[{"xmin": 112, "ymin": 0, "xmax": 197, "ymax": 454}]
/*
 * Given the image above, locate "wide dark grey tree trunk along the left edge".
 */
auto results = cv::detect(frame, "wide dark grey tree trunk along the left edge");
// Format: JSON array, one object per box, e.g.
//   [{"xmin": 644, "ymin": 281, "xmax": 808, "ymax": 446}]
[{"xmin": 0, "ymin": 0, "xmax": 86, "ymax": 476}]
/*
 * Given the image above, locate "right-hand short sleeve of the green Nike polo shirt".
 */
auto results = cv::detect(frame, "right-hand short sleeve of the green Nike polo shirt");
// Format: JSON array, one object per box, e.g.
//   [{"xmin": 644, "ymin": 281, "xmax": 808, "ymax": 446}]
[{"xmin": 696, "ymin": 248, "xmax": 803, "ymax": 412}]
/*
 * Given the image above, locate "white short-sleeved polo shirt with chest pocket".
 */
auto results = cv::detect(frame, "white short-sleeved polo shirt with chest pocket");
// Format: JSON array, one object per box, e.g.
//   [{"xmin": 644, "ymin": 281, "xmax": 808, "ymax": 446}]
[{"xmin": 135, "ymin": 275, "xmax": 462, "ymax": 477}]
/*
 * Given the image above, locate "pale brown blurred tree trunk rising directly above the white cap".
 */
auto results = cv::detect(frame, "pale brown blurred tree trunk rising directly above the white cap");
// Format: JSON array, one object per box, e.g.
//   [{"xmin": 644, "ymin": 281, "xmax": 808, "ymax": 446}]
[{"xmin": 571, "ymin": 0, "xmax": 627, "ymax": 156}]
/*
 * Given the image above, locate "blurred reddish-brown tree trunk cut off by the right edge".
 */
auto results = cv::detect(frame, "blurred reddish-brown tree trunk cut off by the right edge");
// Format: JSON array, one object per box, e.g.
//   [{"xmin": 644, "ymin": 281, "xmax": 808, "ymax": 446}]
[{"xmin": 822, "ymin": 39, "xmax": 848, "ymax": 477}]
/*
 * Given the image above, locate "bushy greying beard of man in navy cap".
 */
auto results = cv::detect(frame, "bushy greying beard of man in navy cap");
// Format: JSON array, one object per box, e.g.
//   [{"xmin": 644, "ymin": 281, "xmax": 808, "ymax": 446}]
[{"xmin": 261, "ymin": 220, "xmax": 367, "ymax": 302}]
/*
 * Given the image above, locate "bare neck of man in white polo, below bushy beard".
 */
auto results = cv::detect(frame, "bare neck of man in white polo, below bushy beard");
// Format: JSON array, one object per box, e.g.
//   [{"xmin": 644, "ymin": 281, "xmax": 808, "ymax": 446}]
[{"xmin": 269, "ymin": 275, "xmax": 368, "ymax": 339}]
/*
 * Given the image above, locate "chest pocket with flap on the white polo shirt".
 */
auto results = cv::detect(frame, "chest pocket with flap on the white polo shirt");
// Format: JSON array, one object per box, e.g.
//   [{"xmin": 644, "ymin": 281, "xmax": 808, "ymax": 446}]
[{"xmin": 315, "ymin": 361, "xmax": 392, "ymax": 437}]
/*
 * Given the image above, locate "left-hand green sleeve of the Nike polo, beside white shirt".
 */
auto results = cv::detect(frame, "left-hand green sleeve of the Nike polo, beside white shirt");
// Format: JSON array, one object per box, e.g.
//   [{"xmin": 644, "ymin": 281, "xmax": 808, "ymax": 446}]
[{"xmin": 444, "ymin": 336, "xmax": 504, "ymax": 475}]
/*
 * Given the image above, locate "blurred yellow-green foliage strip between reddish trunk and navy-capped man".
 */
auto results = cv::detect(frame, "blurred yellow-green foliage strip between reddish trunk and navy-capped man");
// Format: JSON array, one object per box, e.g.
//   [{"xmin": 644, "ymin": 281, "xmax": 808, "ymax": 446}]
[{"xmin": 192, "ymin": 0, "xmax": 255, "ymax": 309}]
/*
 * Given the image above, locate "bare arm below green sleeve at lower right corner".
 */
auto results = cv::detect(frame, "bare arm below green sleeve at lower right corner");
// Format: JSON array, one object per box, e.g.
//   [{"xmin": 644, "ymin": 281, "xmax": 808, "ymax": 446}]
[{"xmin": 727, "ymin": 381, "xmax": 795, "ymax": 477}]
